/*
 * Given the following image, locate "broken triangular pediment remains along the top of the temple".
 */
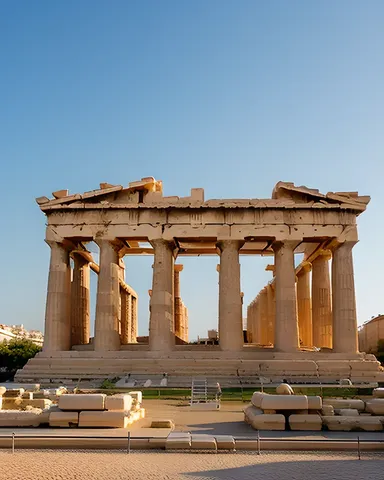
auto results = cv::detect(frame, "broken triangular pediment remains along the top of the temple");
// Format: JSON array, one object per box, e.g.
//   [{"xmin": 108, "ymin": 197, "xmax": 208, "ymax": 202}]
[{"xmin": 36, "ymin": 177, "xmax": 370, "ymax": 214}]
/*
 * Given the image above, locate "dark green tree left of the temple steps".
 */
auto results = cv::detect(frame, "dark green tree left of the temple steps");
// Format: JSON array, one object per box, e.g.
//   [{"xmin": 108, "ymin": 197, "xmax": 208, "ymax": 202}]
[{"xmin": 0, "ymin": 338, "xmax": 41, "ymax": 378}]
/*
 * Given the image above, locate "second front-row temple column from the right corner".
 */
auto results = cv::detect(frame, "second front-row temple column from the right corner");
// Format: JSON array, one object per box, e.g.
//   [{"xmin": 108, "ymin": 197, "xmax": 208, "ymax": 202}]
[{"xmin": 273, "ymin": 241, "xmax": 299, "ymax": 352}]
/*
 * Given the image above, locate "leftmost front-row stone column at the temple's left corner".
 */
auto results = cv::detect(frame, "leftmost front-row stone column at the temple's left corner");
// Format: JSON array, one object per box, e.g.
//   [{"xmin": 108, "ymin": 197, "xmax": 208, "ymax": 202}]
[{"xmin": 44, "ymin": 242, "xmax": 71, "ymax": 351}]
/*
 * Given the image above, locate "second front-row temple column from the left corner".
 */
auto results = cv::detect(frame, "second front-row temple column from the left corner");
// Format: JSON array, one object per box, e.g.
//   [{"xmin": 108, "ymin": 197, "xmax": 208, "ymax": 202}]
[{"xmin": 95, "ymin": 239, "xmax": 121, "ymax": 351}]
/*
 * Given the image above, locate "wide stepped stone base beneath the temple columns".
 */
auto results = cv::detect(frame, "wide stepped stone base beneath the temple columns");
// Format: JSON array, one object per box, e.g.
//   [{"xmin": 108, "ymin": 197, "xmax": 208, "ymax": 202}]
[{"xmin": 15, "ymin": 347, "xmax": 384, "ymax": 387}]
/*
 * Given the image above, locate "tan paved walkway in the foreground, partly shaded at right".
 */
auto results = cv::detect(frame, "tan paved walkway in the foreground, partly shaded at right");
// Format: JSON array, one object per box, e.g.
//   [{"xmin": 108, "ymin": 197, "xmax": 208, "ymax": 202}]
[{"xmin": 0, "ymin": 450, "xmax": 384, "ymax": 480}]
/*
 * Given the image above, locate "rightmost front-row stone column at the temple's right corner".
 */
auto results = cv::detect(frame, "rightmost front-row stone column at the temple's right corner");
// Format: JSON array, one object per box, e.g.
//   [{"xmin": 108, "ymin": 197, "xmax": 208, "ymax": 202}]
[{"xmin": 332, "ymin": 242, "xmax": 359, "ymax": 353}]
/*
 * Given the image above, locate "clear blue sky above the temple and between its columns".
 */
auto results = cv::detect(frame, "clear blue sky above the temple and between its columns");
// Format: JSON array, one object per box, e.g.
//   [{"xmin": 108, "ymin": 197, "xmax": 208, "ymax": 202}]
[{"xmin": 0, "ymin": 0, "xmax": 384, "ymax": 337}]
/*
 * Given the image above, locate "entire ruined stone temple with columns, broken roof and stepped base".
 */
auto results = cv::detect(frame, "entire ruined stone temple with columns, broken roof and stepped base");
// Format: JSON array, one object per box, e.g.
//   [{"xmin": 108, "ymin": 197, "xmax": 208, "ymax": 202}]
[{"xmin": 17, "ymin": 177, "xmax": 383, "ymax": 383}]
